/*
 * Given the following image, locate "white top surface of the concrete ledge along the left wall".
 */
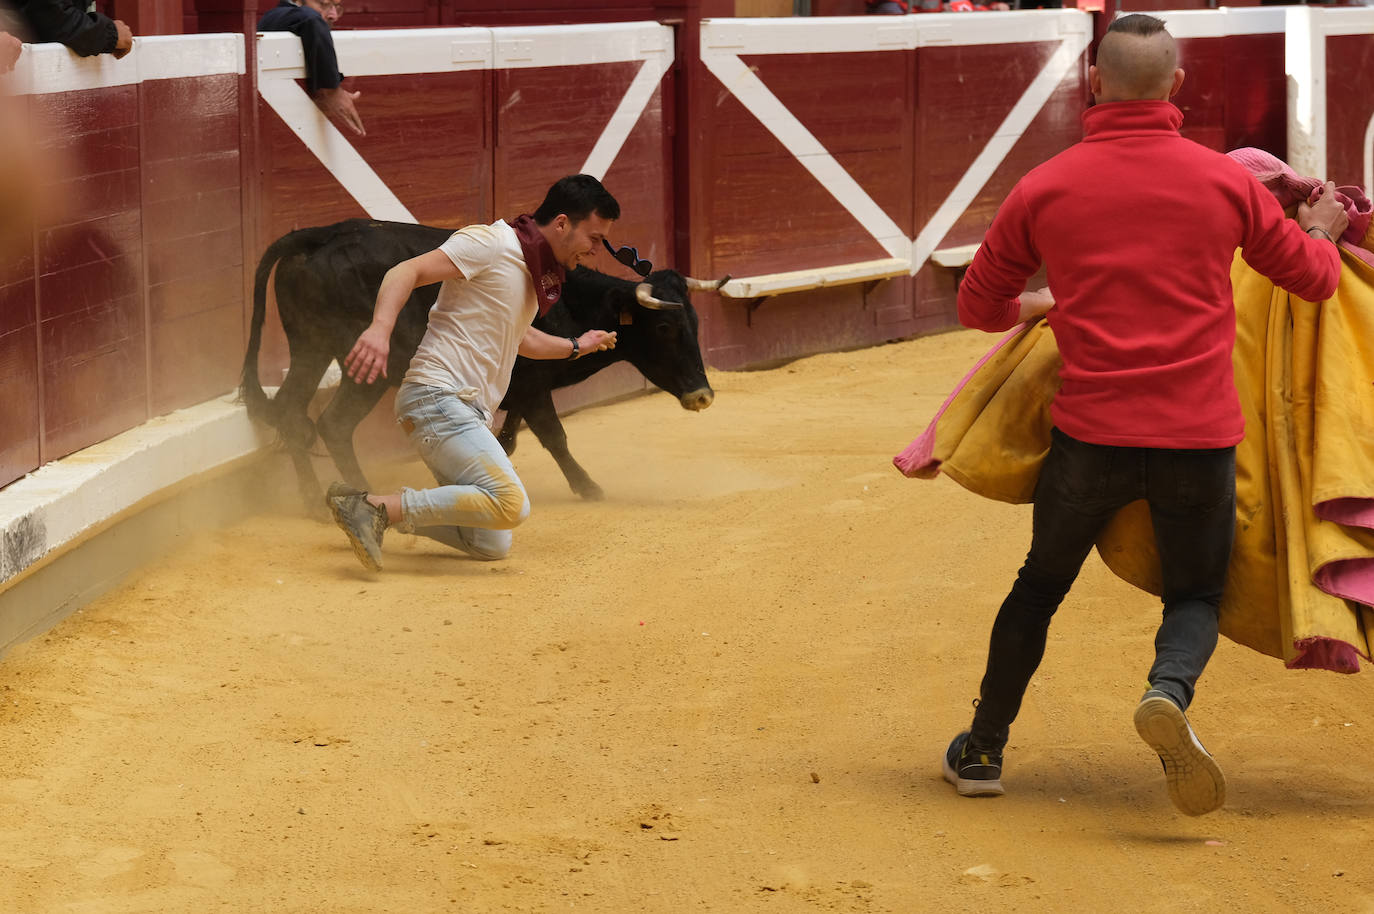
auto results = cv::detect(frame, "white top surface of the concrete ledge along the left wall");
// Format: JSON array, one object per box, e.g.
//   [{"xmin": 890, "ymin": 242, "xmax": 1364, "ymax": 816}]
[{"xmin": 0, "ymin": 394, "xmax": 272, "ymax": 591}]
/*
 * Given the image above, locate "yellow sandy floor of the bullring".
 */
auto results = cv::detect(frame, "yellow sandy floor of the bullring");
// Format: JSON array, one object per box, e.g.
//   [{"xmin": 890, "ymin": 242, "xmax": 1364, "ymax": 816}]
[{"xmin": 0, "ymin": 333, "xmax": 1374, "ymax": 914}]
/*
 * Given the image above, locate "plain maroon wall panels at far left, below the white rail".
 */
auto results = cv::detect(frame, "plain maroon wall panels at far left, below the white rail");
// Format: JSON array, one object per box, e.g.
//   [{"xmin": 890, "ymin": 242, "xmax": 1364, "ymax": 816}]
[{"xmin": 0, "ymin": 45, "xmax": 243, "ymax": 484}]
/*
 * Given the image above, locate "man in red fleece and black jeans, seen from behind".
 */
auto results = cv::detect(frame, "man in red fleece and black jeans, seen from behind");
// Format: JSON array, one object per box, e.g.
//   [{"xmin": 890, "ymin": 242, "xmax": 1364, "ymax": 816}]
[{"xmin": 943, "ymin": 15, "xmax": 1345, "ymax": 815}]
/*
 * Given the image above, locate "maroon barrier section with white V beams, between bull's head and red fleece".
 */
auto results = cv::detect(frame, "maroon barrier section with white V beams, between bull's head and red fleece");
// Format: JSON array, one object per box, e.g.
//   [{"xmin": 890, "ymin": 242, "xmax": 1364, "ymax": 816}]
[{"xmin": 687, "ymin": 10, "xmax": 1092, "ymax": 367}]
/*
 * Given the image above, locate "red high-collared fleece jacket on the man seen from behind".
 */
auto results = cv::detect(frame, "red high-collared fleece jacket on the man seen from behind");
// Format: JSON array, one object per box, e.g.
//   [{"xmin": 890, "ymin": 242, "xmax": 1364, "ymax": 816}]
[{"xmin": 959, "ymin": 102, "xmax": 1341, "ymax": 448}]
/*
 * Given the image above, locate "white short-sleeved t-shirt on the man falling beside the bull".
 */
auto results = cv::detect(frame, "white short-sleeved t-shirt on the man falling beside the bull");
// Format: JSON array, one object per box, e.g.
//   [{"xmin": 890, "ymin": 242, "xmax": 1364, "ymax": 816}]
[{"xmin": 405, "ymin": 220, "xmax": 539, "ymax": 423}]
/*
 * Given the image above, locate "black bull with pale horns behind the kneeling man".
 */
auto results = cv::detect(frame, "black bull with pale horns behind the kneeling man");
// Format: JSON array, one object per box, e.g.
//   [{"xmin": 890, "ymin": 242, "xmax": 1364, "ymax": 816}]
[{"xmin": 239, "ymin": 219, "xmax": 714, "ymax": 511}]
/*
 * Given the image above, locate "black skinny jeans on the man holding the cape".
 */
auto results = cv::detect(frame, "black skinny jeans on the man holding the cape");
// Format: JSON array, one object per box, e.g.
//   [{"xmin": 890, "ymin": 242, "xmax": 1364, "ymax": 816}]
[{"xmin": 971, "ymin": 429, "xmax": 1235, "ymax": 750}]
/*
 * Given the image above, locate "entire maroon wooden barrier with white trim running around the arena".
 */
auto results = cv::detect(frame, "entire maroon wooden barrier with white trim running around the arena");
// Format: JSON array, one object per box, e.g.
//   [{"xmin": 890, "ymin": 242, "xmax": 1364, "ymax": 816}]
[{"xmin": 0, "ymin": 4, "xmax": 1374, "ymax": 485}]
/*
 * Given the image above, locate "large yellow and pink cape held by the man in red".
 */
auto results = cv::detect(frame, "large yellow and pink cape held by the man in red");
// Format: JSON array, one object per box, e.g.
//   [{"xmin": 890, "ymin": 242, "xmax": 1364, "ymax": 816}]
[{"xmin": 893, "ymin": 151, "xmax": 1374, "ymax": 672}]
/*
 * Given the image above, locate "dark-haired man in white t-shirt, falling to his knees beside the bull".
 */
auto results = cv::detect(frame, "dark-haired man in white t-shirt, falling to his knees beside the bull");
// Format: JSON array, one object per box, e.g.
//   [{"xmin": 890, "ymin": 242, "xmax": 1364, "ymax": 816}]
[{"xmin": 326, "ymin": 175, "xmax": 620, "ymax": 572}]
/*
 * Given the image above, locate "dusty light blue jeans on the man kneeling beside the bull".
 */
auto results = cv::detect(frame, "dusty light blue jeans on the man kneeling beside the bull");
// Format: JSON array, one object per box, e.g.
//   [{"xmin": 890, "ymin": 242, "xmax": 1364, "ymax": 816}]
[{"xmin": 396, "ymin": 383, "xmax": 529, "ymax": 561}]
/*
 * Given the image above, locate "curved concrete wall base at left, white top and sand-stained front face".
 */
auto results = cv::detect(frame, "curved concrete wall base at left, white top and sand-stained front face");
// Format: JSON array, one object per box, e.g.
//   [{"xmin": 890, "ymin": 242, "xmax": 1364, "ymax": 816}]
[{"xmin": 0, "ymin": 397, "xmax": 280, "ymax": 653}]
